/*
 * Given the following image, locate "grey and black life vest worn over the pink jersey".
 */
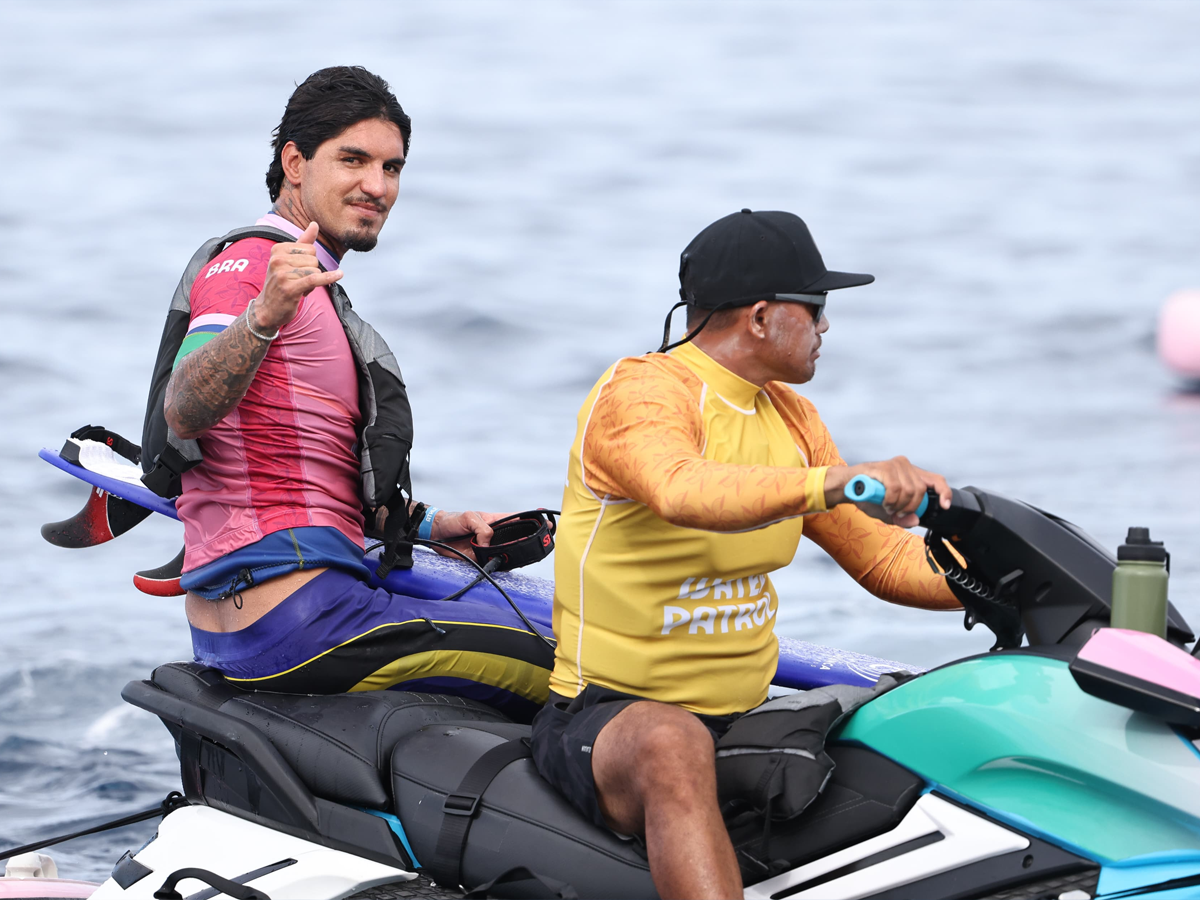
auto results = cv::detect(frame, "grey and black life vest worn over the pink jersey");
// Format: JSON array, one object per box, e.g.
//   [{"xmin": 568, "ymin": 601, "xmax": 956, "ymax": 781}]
[{"xmin": 142, "ymin": 226, "xmax": 413, "ymax": 568}]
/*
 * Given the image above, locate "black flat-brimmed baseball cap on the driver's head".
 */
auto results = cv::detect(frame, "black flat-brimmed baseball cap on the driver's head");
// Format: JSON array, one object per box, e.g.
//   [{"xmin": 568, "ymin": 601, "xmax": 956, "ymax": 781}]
[{"xmin": 679, "ymin": 209, "xmax": 875, "ymax": 310}]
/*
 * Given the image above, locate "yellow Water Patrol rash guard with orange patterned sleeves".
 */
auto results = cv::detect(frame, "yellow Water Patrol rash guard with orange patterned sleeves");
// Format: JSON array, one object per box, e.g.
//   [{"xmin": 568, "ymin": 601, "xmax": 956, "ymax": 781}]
[{"xmin": 550, "ymin": 344, "xmax": 956, "ymax": 715}]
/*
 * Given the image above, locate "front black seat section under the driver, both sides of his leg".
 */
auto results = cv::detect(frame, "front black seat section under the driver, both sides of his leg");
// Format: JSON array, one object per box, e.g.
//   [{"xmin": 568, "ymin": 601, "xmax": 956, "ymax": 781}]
[{"xmin": 391, "ymin": 722, "xmax": 925, "ymax": 898}]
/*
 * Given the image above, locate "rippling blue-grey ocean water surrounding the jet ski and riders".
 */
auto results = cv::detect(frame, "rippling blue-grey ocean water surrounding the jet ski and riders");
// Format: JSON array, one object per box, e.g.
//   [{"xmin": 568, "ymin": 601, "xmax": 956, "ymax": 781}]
[{"xmin": 0, "ymin": 0, "xmax": 1200, "ymax": 880}]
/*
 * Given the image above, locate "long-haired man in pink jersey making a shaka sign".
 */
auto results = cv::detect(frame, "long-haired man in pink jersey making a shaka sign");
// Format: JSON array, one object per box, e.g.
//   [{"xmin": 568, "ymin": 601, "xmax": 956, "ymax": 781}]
[{"xmin": 143, "ymin": 66, "xmax": 551, "ymax": 721}]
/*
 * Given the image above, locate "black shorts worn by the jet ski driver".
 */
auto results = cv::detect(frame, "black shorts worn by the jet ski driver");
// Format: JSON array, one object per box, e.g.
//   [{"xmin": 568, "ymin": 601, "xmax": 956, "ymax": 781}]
[{"xmin": 533, "ymin": 684, "xmax": 740, "ymax": 828}]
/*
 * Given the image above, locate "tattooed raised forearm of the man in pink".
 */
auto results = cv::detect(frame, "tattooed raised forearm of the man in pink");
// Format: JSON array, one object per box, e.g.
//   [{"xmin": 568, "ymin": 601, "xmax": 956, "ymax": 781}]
[{"xmin": 164, "ymin": 312, "xmax": 270, "ymax": 440}]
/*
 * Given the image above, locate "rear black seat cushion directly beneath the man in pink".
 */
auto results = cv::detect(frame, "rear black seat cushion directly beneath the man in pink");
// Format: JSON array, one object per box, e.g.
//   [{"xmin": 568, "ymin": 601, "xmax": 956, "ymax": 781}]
[{"xmin": 151, "ymin": 662, "xmax": 517, "ymax": 809}]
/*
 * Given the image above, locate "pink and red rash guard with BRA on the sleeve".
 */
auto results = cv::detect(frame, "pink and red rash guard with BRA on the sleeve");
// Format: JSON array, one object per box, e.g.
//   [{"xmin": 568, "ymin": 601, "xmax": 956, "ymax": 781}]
[{"xmin": 175, "ymin": 214, "xmax": 364, "ymax": 572}]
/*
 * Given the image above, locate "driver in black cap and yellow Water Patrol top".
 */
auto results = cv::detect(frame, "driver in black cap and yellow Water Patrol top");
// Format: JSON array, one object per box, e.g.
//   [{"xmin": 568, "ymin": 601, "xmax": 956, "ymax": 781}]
[{"xmin": 533, "ymin": 209, "xmax": 960, "ymax": 898}]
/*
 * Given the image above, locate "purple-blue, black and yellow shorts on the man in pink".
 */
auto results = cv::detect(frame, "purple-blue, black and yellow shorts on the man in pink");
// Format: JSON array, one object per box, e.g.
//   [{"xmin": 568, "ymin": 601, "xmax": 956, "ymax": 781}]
[{"xmin": 192, "ymin": 569, "xmax": 554, "ymax": 722}]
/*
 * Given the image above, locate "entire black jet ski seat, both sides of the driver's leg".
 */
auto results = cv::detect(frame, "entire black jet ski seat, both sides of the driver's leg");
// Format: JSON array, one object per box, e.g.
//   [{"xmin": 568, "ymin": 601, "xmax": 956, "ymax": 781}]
[{"xmin": 122, "ymin": 662, "xmax": 925, "ymax": 898}]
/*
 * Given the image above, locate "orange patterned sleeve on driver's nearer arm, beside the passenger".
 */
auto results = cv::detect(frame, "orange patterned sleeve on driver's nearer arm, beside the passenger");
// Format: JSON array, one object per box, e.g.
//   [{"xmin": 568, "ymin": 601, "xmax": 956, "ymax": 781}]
[{"xmin": 581, "ymin": 358, "xmax": 826, "ymax": 532}]
